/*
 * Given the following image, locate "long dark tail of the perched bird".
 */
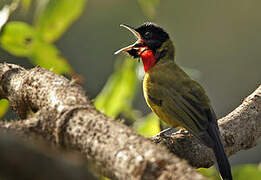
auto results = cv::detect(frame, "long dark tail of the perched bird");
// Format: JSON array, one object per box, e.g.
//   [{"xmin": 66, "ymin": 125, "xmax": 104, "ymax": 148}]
[{"xmin": 208, "ymin": 123, "xmax": 233, "ymax": 180}]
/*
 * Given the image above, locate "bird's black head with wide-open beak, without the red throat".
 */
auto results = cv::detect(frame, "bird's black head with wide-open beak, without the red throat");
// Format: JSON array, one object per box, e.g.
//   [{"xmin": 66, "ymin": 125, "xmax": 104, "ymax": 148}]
[{"xmin": 115, "ymin": 22, "xmax": 169, "ymax": 58}]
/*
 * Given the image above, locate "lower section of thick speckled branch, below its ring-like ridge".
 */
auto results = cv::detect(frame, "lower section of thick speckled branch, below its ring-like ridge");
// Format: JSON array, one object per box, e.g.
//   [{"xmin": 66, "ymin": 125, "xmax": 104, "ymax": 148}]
[{"xmin": 63, "ymin": 107, "xmax": 203, "ymax": 179}]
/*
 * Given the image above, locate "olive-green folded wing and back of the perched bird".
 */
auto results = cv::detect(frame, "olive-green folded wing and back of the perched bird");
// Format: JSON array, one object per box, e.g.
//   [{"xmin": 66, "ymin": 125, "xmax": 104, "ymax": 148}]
[{"xmin": 148, "ymin": 64, "xmax": 215, "ymax": 139}]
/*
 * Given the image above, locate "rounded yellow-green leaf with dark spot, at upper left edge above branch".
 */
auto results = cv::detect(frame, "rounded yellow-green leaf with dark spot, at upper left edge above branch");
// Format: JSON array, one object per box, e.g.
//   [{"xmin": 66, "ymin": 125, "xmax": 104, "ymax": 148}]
[{"xmin": 0, "ymin": 21, "xmax": 38, "ymax": 56}]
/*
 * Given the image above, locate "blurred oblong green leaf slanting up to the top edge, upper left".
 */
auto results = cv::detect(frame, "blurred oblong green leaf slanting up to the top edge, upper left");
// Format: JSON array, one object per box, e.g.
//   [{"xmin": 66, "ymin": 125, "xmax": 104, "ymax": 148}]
[{"xmin": 35, "ymin": 0, "xmax": 86, "ymax": 42}]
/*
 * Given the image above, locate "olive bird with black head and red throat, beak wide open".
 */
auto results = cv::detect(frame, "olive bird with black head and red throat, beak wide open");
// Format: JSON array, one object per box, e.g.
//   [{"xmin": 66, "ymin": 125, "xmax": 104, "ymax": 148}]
[{"xmin": 114, "ymin": 22, "xmax": 232, "ymax": 180}]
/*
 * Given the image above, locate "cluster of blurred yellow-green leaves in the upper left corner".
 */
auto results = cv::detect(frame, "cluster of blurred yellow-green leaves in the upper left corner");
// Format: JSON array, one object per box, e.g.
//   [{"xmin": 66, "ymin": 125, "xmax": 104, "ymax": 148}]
[{"xmin": 0, "ymin": 0, "xmax": 86, "ymax": 75}]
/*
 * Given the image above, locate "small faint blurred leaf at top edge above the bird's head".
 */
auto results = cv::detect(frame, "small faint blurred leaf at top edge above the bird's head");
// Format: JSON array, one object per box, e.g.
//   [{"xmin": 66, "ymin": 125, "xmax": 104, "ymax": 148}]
[{"xmin": 137, "ymin": 0, "xmax": 160, "ymax": 19}]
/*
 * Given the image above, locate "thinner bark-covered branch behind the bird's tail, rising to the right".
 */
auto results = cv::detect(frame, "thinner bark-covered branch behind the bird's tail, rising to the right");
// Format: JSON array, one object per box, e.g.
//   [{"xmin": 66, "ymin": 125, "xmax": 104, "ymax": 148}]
[{"xmin": 153, "ymin": 86, "xmax": 261, "ymax": 167}]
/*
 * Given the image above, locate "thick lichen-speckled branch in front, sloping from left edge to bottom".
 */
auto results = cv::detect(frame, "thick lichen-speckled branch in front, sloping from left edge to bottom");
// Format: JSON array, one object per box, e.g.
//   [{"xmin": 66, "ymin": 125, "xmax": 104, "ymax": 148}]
[{"xmin": 0, "ymin": 64, "xmax": 204, "ymax": 180}]
